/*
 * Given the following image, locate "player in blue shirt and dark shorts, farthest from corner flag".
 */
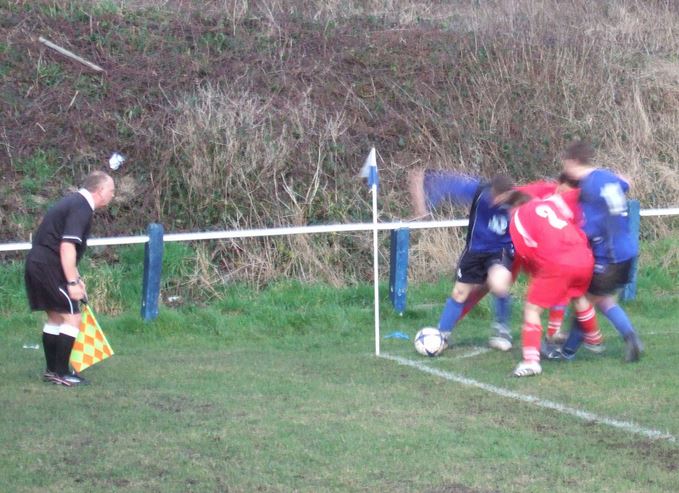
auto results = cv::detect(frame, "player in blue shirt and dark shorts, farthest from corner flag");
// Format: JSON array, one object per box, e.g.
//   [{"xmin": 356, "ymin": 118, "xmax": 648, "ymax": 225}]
[{"xmin": 557, "ymin": 141, "xmax": 643, "ymax": 362}]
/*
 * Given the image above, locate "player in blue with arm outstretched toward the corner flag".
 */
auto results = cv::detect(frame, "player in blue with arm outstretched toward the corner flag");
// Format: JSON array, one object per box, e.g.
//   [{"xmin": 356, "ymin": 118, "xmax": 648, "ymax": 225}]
[{"xmin": 410, "ymin": 170, "xmax": 514, "ymax": 351}]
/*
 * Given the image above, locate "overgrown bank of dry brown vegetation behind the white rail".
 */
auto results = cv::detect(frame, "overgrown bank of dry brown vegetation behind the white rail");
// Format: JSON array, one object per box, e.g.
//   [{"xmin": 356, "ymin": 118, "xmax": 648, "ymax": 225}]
[{"xmin": 0, "ymin": 0, "xmax": 679, "ymax": 284}]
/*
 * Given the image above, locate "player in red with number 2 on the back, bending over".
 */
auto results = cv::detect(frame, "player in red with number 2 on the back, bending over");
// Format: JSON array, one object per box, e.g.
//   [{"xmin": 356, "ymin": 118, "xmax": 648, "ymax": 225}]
[{"xmin": 509, "ymin": 192, "xmax": 600, "ymax": 377}]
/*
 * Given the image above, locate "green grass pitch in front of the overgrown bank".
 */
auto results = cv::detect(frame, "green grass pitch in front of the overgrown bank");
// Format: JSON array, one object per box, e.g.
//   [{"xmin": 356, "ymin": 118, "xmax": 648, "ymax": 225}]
[{"xmin": 0, "ymin": 270, "xmax": 679, "ymax": 492}]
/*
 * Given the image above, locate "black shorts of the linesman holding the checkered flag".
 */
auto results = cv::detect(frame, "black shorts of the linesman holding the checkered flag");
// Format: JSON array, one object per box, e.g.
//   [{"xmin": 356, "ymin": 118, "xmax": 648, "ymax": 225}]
[{"xmin": 24, "ymin": 255, "xmax": 80, "ymax": 314}]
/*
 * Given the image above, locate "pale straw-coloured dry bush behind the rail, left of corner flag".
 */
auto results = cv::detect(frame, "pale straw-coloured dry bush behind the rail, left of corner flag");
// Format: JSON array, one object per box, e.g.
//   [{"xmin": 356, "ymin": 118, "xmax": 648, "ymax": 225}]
[{"xmin": 172, "ymin": 87, "xmax": 378, "ymax": 285}]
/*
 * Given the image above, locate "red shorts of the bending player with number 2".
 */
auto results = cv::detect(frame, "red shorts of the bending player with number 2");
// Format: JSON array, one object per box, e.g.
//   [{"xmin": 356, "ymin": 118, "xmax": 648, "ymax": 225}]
[{"xmin": 526, "ymin": 263, "xmax": 592, "ymax": 308}]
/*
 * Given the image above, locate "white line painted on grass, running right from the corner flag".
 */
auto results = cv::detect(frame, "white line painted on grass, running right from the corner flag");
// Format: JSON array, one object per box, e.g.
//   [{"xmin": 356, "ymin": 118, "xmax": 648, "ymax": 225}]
[{"xmin": 380, "ymin": 354, "xmax": 677, "ymax": 443}]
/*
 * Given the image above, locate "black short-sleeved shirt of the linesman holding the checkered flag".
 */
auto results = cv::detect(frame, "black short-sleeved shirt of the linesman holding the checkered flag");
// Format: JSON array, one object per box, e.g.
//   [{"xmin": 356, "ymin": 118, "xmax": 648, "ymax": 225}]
[{"xmin": 30, "ymin": 193, "xmax": 94, "ymax": 263}]
